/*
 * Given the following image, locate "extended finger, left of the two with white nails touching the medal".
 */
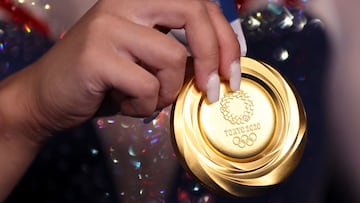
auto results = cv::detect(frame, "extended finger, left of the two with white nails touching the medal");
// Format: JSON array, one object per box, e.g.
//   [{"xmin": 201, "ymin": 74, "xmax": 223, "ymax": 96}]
[{"xmin": 101, "ymin": 0, "xmax": 226, "ymax": 102}]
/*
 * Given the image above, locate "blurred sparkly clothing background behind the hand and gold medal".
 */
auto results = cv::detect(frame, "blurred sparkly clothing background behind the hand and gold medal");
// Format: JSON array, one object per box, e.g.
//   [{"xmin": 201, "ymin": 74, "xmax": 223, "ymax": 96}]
[{"xmin": 0, "ymin": 0, "xmax": 360, "ymax": 203}]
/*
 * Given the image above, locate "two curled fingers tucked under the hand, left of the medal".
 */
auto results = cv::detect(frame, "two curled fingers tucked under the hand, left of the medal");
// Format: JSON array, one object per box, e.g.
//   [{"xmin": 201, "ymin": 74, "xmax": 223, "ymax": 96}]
[{"xmin": 94, "ymin": 17, "xmax": 187, "ymax": 116}]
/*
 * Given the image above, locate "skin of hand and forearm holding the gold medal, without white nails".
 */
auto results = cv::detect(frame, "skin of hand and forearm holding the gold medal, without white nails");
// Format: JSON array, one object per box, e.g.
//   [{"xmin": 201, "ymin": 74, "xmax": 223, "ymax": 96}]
[{"xmin": 0, "ymin": 0, "xmax": 240, "ymax": 201}]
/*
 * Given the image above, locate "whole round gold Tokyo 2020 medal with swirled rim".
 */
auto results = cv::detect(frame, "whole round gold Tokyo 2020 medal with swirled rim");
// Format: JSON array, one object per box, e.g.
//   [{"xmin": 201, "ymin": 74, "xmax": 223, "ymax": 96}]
[{"xmin": 171, "ymin": 57, "xmax": 306, "ymax": 196}]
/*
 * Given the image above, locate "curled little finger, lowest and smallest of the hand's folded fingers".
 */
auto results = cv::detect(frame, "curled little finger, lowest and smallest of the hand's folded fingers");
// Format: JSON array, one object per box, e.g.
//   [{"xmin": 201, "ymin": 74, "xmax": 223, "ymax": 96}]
[{"xmin": 100, "ymin": 54, "xmax": 160, "ymax": 116}]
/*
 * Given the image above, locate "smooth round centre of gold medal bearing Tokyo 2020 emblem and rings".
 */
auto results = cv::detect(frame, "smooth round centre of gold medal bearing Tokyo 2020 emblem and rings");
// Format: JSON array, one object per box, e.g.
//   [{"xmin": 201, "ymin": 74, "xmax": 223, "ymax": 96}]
[{"xmin": 199, "ymin": 78, "xmax": 277, "ymax": 160}]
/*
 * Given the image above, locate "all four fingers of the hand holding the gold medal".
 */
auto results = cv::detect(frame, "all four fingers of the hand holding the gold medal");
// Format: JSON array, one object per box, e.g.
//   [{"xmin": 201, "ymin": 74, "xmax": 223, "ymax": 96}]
[{"xmin": 93, "ymin": 0, "xmax": 241, "ymax": 114}]
